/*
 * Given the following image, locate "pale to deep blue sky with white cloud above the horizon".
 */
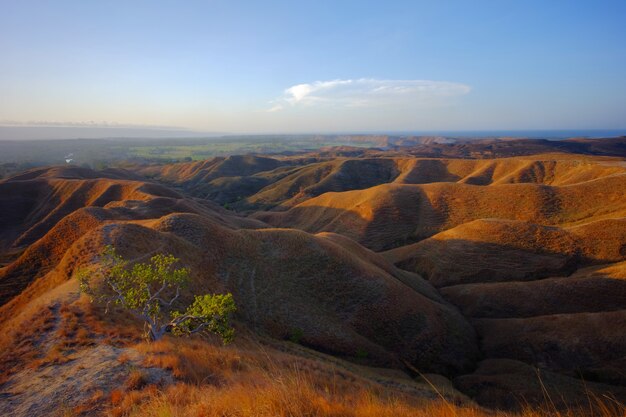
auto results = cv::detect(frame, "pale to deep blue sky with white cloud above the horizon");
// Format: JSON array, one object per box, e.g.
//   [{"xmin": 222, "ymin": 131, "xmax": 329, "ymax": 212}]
[{"xmin": 0, "ymin": 0, "xmax": 626, "ymax": 133}]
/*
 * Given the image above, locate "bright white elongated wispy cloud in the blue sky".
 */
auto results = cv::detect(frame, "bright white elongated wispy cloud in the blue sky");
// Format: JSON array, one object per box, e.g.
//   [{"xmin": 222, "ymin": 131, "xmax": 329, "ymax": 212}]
[{"xmin": 268, "ymin": 78, "xmax": 471, "ymax": 112}]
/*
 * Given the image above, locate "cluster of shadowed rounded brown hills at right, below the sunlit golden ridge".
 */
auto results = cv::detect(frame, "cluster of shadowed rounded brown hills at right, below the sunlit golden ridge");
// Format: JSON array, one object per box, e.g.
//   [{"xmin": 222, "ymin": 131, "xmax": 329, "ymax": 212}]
[{"xmin": 385, "ymin": 218, "xmax": 626, "ymax": 385}]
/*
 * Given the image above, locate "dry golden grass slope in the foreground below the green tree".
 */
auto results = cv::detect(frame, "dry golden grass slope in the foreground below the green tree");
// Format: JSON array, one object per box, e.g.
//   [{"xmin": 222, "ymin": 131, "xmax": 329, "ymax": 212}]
[{"xmin": 97, "ymin": 340, "xmax": 626, "ymax": 417}]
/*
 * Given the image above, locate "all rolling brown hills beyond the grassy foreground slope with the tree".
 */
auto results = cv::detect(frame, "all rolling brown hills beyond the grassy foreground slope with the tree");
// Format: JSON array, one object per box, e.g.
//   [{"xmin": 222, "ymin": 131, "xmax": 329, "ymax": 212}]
[{"xmin": 0, "ymin": 147, "xmax": 626, "ymax": 407}]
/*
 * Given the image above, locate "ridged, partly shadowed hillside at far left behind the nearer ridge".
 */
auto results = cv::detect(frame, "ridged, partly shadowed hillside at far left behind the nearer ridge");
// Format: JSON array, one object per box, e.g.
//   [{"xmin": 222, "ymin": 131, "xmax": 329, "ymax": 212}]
[{"xmin": 0, "ymin": 164, "xmax": 264, "ymax": 302}]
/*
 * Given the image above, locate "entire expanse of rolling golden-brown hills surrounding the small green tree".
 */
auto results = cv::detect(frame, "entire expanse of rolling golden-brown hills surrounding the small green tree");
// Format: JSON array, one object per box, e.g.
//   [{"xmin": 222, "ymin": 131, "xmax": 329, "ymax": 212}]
[{"xmin": 0, "ymin": 138, "xmax": 626, "ymax": 416}]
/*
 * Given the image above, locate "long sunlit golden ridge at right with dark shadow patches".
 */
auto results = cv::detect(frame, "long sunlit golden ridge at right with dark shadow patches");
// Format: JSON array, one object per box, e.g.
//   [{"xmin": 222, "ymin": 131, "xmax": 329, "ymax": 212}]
[{"xmin": 252, "ymin": 165, "xmax": 626, "ymax": 251}]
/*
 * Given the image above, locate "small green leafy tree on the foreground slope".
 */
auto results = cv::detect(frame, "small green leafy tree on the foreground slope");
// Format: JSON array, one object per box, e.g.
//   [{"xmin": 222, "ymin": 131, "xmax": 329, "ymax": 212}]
[{"xmin": 77, "ymin": 245, "xmax": 236, "ymax": 343}]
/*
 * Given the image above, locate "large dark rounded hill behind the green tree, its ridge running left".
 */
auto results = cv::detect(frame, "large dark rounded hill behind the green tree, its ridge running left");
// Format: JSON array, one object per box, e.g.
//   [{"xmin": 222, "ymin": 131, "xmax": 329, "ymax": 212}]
[{"xmin": 0, "ymin": 167, "xmax": 476, "ymax": 373}]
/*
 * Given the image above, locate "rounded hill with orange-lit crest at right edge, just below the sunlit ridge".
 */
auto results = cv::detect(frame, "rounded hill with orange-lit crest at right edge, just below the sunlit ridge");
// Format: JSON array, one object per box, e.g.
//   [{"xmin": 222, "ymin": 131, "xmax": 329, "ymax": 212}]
[{"xmin": 385, "ymin": 218, "xmax": 626, "ymax": 287}]
